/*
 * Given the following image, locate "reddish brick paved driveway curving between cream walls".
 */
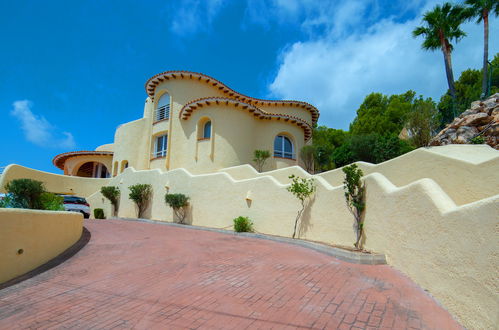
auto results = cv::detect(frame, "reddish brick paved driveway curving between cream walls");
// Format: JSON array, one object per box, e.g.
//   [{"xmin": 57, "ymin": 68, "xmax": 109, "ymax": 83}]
[{"xmin": 0, "ymin": 220, "xmax": 459, "ymax": 329}]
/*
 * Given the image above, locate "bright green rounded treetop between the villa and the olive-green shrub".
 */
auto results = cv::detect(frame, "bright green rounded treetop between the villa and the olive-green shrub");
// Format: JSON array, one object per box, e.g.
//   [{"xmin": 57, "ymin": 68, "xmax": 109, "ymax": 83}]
[{"xmin": 350, "ymin": 91, "xmax": 416, "ymax": 135}]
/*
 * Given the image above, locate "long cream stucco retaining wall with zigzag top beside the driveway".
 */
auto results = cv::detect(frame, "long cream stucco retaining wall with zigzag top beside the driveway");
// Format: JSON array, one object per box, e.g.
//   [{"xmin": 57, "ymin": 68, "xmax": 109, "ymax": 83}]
[{"xmin": 84, "ymin": 146, "xmax": 499, "ymax": 329}]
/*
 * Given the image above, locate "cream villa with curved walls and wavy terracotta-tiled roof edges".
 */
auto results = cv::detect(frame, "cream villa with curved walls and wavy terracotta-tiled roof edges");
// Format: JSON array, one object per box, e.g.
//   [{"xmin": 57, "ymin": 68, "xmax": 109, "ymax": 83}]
[{"xmin": 53, "ymin": 71, "xmax": 319, "ymax": 178}]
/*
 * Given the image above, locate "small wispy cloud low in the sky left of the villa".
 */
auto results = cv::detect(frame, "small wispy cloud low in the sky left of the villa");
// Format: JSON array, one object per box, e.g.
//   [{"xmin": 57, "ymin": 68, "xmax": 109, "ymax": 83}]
[{"xmin": 11, "ymin": 100, "xmax": 76, "ymax": 149}]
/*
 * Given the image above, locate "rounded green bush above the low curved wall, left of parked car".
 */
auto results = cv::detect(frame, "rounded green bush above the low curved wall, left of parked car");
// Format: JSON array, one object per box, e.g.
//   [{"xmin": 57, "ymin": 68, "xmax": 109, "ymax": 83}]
[{"xmin": 5, "ymin": 179, "xmax": 45, "ymax": 209}]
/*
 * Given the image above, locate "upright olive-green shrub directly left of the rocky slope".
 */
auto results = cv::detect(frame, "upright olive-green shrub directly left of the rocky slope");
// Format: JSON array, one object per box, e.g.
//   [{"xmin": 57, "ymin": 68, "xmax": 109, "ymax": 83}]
[{"xmin": 407, "ymin": 96, "xmax": 440, "ymax": 147}]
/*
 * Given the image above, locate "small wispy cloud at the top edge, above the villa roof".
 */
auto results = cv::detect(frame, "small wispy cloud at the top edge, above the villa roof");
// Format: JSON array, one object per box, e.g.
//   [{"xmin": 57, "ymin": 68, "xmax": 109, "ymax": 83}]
[{"xmin": 169, "ymin": 0, "xmax": 226, "ymax": 36}]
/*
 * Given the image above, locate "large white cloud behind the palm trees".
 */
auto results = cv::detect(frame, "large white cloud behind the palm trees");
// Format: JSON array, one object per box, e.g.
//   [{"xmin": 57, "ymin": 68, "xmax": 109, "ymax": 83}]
[{"xmin": 269, "ymin": 0, "xmax": 499, "ymax": 128}]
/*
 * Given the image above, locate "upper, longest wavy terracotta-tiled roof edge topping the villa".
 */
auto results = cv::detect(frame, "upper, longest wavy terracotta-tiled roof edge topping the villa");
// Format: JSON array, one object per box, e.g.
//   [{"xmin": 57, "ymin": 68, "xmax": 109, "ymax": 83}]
[{"xmin": 145, "ymin": 71, "xmax": 319, "ymax": 124}]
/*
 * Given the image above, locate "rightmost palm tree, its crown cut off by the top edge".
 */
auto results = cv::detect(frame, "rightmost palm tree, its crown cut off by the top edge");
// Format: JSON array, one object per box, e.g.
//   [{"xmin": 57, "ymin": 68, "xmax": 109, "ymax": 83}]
[{"xmin": 465, "ymin": 0, "xmax": 499, "ymax": 97}]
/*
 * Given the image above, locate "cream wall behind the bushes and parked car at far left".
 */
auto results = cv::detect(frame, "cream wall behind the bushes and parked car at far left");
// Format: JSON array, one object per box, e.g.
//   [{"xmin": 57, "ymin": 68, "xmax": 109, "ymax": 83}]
[{"xmin": 0, "ymin": 164, "xmax": 110, "ymax": 197}]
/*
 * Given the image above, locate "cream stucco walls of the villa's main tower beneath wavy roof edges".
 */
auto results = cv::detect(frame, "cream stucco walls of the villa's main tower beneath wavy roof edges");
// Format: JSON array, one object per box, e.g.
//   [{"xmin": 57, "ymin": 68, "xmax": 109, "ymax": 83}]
[{"xmin": 111, "ymin": 75, "xmax": 312, "ymax": 174}]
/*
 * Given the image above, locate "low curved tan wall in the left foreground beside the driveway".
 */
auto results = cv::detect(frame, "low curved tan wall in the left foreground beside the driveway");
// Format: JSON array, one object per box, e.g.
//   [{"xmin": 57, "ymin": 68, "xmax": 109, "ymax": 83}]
[{"xmin": 0, "ymin": 209, "xmax": 83, "ymax": 283}]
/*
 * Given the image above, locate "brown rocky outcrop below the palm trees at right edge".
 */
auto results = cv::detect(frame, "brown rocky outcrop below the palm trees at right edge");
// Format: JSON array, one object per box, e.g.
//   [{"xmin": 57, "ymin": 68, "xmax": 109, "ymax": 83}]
[{"xmin": 430, "ymin": 93, "xmax": 499, "ymax": 150}]
